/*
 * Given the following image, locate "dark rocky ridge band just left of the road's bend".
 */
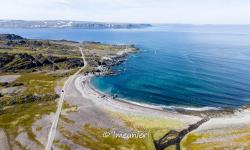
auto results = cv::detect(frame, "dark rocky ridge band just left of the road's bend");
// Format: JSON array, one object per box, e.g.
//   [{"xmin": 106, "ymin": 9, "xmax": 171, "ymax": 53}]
[{"xmin": 0, "ymin": 53, "xmax": 83, "ymax": 72}]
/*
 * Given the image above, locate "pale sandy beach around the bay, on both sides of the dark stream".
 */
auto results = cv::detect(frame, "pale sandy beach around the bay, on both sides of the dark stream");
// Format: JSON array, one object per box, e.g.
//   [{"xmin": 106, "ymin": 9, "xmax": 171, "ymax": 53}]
[{"xmin": 80, "ymin": 75, "xmax": 250, "ymax": 131}]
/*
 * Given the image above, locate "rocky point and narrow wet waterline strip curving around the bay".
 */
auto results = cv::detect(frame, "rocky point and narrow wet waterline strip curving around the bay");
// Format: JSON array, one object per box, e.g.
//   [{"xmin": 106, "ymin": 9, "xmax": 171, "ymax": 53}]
[{"xmin": 85, "ymin": 45, "xmax": 242, "ymax": 116}]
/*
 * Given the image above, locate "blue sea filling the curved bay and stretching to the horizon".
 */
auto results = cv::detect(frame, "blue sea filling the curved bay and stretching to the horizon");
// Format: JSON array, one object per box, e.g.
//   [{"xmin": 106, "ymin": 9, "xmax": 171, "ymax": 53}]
[{"xmin": 0, "ymin": 25, "xmax": 250, "ymax": 108}]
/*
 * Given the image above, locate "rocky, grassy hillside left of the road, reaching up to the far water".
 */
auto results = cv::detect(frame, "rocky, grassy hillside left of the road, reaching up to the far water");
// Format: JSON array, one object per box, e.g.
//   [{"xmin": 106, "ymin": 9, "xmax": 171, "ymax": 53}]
[{"xmin": 0, "ymin": 35, "xmax": 83, "ymax": 72}]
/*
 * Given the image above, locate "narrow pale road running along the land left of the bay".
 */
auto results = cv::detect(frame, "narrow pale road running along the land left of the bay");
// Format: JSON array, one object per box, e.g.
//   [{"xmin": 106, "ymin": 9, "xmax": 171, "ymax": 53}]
[{"xmin": 46, "ymin": 47, "xmax": 87, "ymax": 150}]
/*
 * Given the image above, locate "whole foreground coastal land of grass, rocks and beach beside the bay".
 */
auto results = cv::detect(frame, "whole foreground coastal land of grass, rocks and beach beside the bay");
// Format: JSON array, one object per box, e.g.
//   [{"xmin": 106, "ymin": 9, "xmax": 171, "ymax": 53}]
[{"xmin": 0, "ymin": 34, "xmax": 250, "ymax": 149}]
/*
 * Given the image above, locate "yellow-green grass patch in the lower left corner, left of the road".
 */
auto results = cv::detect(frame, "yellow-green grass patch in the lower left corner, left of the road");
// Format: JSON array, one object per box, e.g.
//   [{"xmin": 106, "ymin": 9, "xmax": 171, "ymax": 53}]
[{"xmin": 0, "ymin": 101, "xmax": 56, "ymax": 149}]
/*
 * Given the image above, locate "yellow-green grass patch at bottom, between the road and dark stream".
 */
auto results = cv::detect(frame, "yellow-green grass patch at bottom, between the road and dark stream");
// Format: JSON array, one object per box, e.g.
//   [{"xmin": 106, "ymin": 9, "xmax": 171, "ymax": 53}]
[{"xmin": 60, "ymin": 124, "xmax": 154, "ymax": 150}]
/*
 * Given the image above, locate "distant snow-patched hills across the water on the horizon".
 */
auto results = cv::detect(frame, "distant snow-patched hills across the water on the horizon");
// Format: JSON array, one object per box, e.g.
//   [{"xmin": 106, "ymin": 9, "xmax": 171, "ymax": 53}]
[{"xmin": 0, "ymin": 20, "xmax": 151, "ymax": 29}]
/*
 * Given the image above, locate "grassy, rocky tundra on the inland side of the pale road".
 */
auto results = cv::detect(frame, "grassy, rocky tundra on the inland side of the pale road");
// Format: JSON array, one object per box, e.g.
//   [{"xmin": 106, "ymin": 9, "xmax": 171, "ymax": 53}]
[{"xmin": 0, "ymin": 34, "xmax": 139, "ymax": 149}]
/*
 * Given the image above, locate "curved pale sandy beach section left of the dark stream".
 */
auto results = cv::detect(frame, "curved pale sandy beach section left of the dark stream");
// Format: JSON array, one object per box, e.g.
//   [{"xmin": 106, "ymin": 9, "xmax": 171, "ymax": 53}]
[{"xmin": 75, "ymin": 76, "xmax": 201, "ymax": 124}]
